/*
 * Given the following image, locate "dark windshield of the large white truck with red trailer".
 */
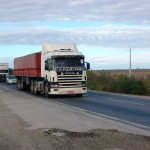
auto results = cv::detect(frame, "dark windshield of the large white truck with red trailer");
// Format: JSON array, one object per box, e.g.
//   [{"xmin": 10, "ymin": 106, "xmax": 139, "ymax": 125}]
[{"xmin": 55, "ymin": 58, "xmax": 84, "ymax": 67}]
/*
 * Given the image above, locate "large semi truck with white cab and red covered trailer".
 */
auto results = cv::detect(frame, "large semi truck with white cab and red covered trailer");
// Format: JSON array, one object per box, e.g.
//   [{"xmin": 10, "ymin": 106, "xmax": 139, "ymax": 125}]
[{"xmin": 14, "ymin": 43, "xmax": 90, "ymax": 97}]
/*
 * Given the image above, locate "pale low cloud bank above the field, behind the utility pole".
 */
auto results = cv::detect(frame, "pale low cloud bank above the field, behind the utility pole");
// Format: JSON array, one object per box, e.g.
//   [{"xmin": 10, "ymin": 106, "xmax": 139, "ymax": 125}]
[{"xmin": 87, "ymin": 52, "xmax": 150, "ymax": 70}]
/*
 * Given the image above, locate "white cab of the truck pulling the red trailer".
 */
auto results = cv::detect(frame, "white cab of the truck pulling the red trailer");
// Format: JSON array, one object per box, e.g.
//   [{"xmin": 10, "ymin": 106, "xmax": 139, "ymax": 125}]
[{"xmin": 41, "ymin": 44, "xmax": 90, "ymax": 96}]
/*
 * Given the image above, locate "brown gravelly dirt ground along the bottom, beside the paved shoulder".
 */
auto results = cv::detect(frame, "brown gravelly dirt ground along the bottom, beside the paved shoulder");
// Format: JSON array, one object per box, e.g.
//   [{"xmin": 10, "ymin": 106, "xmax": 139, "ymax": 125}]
[{"xmin": 0, "ymin": 100, "xmax": 150, "ymax": 150}]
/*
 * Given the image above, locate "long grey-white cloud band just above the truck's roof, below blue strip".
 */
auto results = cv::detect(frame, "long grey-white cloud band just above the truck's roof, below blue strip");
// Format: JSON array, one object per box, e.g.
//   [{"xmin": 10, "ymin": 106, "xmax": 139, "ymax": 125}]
[{"xmin": 0, "ymin": 24, "xmax": 150, "ymax": 48}]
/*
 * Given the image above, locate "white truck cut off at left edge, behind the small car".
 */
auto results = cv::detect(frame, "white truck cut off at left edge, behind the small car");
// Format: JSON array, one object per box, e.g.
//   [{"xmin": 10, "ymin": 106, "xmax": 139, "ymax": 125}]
[{"xmin": 0, "ymin": 63, "xmax": 9, "ymax": 82}]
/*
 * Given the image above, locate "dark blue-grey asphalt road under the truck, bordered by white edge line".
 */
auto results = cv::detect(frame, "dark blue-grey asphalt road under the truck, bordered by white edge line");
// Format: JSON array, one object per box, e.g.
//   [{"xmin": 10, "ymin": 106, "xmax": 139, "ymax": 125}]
[{"xmin": 1, "ymin": 83, "xmax": 150, "ymax": 130}]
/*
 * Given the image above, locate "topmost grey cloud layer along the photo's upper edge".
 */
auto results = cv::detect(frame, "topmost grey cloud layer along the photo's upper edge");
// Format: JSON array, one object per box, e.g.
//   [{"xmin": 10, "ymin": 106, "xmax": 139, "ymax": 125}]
[{"xmin": 0, "ymin": 0, "xmax": 150, "ymax": 24}]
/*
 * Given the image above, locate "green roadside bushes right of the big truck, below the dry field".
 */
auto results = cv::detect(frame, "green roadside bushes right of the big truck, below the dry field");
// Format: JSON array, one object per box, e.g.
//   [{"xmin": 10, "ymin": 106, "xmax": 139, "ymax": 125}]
[{"xmin": 87, "ymin": 70, "xmax": 150, "ymax": 95}]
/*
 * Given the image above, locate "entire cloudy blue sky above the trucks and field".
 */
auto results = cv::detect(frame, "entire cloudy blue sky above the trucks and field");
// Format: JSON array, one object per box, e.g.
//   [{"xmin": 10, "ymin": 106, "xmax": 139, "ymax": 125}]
[{"xmin": 0, "ymin": 0, "xmax": 150, "ymax": 70}]
